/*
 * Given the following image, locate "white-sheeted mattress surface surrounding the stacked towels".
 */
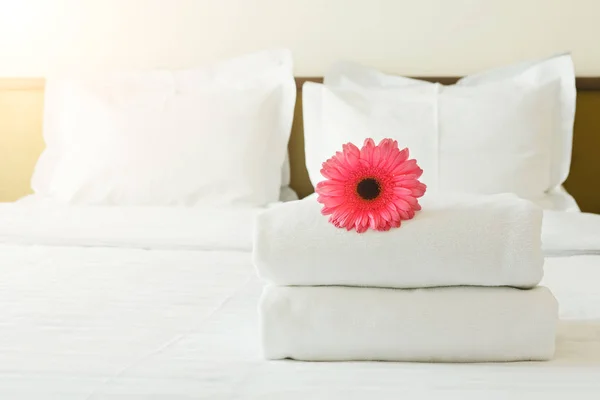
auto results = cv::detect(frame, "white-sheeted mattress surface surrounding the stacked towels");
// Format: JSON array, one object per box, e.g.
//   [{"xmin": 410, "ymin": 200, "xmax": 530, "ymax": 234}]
[{"xmin": 0, "ymin": 202, "xmax": 600, "ymax": 400}]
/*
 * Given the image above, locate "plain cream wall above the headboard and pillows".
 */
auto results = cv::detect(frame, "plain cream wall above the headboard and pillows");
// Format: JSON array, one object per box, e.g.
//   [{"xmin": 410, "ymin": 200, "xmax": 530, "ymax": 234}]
[{"xmin": 0, "ymin": 0, "xmax": 600, "ymax": 76}]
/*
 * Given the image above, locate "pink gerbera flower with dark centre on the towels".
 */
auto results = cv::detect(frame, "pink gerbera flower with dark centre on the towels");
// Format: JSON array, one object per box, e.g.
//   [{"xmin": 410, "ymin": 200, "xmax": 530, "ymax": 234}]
[{"xmin": 316, "ymin": 139, "xmax": 426, "ymax": 233}]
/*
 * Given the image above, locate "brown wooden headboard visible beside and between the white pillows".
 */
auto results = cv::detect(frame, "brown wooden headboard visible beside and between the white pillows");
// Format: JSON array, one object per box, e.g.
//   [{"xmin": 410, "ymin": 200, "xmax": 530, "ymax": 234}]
[{"xmin": 0, "ymin": 77, "xmax": 600, "ymax": 213}]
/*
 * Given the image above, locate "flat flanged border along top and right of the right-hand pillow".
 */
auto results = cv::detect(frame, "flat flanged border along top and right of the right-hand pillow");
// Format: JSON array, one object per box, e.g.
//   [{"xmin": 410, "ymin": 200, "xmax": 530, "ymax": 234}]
[{"xmin": 325, "ymin": 54, "xmax": 576, "ymax": 210}]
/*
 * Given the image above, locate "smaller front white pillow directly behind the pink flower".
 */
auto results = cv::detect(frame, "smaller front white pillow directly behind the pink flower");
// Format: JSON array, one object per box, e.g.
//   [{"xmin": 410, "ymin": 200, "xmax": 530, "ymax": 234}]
[{"xmin": 302, "ymin": 82, "xmax": 438, "ymax": 186}]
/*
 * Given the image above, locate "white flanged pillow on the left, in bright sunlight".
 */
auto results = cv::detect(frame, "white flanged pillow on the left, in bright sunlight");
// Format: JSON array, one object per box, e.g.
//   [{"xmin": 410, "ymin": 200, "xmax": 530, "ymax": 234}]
[{"xmin": 32, "ymin": 50, "xmax": 296, "ymax": 206}]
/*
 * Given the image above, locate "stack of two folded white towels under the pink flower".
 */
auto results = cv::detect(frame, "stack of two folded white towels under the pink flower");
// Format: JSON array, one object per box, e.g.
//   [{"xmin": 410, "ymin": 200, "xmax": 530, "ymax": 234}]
[{"xmin": 253, "ymin": 194, "xmax": 558, "ymax": 362}]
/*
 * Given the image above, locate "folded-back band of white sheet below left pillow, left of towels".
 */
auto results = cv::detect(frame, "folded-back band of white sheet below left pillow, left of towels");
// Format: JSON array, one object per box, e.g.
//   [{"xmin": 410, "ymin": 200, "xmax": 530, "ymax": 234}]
[{"xmin": 0, "ymin": 202, "xmax": 264, "ymax": 251}]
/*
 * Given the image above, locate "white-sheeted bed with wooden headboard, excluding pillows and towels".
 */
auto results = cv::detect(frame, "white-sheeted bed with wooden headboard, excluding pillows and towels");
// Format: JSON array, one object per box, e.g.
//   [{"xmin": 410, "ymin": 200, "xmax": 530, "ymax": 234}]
[{"xmin": 0, "ymin": 52, "xmax": 600, "ymax": 400}]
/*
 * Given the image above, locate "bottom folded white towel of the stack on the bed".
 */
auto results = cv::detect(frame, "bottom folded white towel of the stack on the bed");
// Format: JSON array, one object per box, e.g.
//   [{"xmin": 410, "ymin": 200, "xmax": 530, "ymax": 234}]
[{"xmin": 259, "ymin": 286, "xmax": 558, "ymax": 362}]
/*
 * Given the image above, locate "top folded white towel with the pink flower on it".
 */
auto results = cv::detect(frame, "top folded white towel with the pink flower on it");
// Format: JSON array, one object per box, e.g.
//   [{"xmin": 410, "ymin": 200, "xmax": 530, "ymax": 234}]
[{"xmin": 253, "ymin": 194, "xmax": 544, "ymax": 288}]
